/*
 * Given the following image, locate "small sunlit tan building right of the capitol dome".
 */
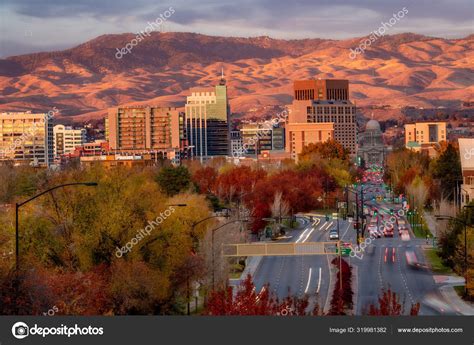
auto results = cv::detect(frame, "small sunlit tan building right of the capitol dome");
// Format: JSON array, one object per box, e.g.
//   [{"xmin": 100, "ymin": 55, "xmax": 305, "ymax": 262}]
[{"xmin": 405, "ymin": 122, "xmax": 447, "ymax": 157}]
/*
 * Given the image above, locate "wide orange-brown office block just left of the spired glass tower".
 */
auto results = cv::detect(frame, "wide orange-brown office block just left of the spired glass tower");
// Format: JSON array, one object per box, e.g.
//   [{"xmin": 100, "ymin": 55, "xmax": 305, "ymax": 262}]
[{"xmin": 106, "ymin": 106, "xmax": 187, "ymax": 159}]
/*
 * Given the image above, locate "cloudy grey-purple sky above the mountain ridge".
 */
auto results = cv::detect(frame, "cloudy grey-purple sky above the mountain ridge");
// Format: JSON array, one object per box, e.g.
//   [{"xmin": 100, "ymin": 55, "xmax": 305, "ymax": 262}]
[{"xmin": 0, "ymin": 0, "xmax": 474, "ymax": 57}]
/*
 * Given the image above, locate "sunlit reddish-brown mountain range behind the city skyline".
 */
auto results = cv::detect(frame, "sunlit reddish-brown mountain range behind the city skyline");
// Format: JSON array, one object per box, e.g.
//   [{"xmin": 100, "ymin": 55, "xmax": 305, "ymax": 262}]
[{"xmin": 0, "ymin": 32, "xmax": 474, "ymax": 122}]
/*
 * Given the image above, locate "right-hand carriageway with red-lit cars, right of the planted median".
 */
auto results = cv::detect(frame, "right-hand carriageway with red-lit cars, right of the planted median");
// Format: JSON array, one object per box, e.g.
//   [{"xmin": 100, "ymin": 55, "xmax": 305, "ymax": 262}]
[{"xmin": 351, "ymin": 187, "xmax": 452, "ymax": 315}]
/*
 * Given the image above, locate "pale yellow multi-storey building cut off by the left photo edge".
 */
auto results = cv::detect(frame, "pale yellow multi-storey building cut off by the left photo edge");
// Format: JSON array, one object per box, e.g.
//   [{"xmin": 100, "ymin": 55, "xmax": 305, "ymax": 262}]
[{"xmin": 0, "ymin": 112, "xmax": 53, "ymax": 167}]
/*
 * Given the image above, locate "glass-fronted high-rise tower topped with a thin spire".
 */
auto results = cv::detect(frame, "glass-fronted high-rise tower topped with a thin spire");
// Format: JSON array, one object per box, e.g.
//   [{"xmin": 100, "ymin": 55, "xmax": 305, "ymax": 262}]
[{"xmin": 185, "ymin": 75, "xmax": 230, "ymax": 159}]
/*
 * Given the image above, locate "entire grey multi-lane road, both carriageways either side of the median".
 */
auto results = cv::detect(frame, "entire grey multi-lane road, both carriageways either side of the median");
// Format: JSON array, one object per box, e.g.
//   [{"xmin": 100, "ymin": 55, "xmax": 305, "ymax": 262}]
[{"xmin": 254, "ymin": 171, "xmax": 459, "ymax": 315}]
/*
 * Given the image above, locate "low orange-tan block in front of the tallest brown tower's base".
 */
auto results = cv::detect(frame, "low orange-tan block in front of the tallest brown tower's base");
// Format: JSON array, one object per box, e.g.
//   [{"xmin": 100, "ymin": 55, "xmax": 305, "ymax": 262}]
[{"xmin": 286, "ymin": 122, "xmax": 334, "ymax": 160}]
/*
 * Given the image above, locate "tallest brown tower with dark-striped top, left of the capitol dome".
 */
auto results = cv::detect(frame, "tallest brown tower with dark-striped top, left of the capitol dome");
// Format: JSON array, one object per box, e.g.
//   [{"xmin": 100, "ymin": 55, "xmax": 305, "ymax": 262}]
[{"xmin": 288, "ymin": 79, "xmax": 357, "ymax": 155}]
